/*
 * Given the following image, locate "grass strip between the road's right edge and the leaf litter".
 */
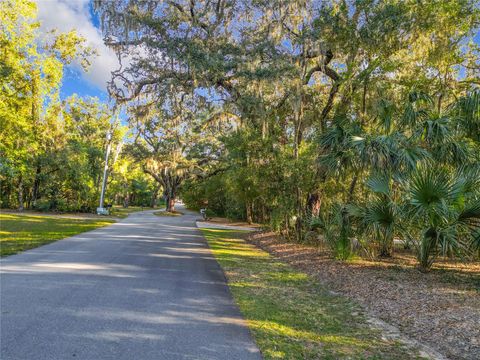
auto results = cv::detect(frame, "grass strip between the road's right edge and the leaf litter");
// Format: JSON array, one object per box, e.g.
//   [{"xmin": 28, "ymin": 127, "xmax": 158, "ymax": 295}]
[{"xmin": 202, "ymin": 229, "xmax": 420, "ymax": 359}]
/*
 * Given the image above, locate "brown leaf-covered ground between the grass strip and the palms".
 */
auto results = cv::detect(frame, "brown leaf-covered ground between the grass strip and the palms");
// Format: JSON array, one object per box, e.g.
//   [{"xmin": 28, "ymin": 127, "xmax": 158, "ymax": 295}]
[{"xmin": 247, "ymin": 232, "xmax": 480, "ymax": 360}]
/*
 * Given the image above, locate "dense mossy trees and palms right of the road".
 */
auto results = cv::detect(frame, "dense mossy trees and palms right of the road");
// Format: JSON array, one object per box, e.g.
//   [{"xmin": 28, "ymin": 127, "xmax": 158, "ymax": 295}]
[{"xmin": 96, "ymin": 0, "xmax": 480, "ymax": 268}]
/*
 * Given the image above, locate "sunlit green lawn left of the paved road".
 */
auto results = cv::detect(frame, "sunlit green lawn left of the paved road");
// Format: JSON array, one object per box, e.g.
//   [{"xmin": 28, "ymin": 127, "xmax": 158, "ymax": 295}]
[{"xmin": 0, "ymin": 214, "xmax": 114, "ymax": 256}]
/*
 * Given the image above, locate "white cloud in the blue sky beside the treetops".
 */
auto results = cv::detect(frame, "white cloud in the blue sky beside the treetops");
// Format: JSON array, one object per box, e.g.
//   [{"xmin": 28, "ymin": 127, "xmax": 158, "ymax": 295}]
[{"xmin": 36, "ymin": 0, "xmax": 118, "ymax": 91}]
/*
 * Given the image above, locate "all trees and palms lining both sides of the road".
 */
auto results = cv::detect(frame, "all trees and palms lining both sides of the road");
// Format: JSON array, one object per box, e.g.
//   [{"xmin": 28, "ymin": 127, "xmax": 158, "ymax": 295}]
[{"xmin": 4, "ymin": 0, "xmax": 480, "ymax": 272}]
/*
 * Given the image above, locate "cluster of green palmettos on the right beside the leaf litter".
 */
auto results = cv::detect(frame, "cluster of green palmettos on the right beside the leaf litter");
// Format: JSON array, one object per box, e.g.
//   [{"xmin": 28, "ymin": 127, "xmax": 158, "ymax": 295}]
[{"xmin": 334, "ymin": 92, "xmax": 480, "ymax": 269}]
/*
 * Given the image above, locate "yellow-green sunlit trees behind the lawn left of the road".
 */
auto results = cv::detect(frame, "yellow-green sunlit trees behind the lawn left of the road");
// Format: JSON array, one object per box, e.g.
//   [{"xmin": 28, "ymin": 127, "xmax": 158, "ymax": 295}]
[{"xmin": 0, "ymin": 0, "xmax": 158, "ymax": 211}]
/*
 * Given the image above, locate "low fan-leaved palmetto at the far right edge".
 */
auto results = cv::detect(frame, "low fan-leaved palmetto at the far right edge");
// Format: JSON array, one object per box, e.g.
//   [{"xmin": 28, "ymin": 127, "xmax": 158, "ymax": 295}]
[{"xmin": 403, "ymin": 165, "xmax": 480, "ymax": 270}]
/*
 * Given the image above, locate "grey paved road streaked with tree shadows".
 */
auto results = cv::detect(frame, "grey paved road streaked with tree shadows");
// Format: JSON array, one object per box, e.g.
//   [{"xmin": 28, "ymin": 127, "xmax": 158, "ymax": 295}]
[{"xmin": 0, "ymin": 207, "xmax": 261, "ymax": 360}]
